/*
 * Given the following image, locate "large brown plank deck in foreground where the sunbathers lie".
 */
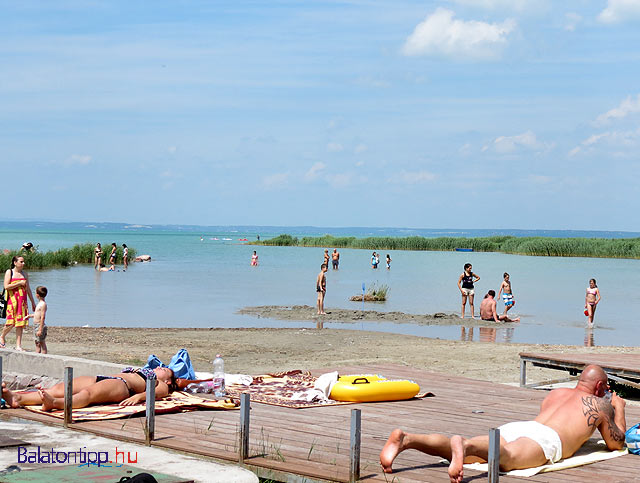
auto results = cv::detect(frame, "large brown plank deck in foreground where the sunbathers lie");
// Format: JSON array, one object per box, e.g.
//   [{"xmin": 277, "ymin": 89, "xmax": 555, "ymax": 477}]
[{"xmin": 5, "ymin": 365, "xmax": 640, "ymax": 483}]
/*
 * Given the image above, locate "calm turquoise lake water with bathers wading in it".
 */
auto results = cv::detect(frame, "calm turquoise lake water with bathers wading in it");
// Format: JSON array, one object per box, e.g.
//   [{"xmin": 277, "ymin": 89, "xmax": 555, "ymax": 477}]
[{"xmin": 0, "ymin": 222, "xmax": 640, "ymax": 346}]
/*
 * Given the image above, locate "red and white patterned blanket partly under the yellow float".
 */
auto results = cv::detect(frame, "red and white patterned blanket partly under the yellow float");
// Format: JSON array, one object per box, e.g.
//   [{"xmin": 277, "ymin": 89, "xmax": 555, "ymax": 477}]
[{"xmin": 227, "ymin": 370, "xmax": 433, "ymax": 409}]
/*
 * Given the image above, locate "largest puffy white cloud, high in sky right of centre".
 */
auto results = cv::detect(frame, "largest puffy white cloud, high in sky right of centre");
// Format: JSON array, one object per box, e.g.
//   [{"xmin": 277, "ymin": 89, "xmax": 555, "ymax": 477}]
[{"xmin": 402, "ymin": 7, "xmax": 516, "ymax": 59}]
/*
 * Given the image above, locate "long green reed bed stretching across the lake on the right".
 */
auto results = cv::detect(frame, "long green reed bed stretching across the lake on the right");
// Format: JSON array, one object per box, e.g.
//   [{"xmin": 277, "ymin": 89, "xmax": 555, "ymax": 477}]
[{"xmin": 253, "ymin": 235, "xmax": 640, "ymax": 258}]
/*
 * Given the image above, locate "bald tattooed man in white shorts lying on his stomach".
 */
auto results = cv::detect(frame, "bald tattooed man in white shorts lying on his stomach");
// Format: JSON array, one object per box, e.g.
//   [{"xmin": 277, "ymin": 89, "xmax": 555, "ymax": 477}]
[{"xmin": 380, "ymin": 365, "xmax": 626, "ymax": 483}]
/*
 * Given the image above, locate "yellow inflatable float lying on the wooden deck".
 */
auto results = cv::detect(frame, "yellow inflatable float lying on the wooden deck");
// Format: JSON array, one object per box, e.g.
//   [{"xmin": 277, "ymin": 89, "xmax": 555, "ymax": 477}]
[{"xmin": 329, "ymin": 374, "xmax": 420, "ymax": 402}]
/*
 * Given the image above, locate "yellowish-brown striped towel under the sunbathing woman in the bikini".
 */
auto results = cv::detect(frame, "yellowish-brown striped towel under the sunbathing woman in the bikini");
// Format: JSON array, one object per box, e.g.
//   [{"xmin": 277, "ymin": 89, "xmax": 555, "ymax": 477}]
[{"xmin": 24, "ymin": 391, "xmax": 238, "ymax": 421}]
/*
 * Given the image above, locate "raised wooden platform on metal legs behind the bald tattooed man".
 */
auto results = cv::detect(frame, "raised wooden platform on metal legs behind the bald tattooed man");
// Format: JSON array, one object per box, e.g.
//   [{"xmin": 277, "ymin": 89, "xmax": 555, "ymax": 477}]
[{"xmin": 520, "ymin": 352, "xmax": 640, "ymax": 388}]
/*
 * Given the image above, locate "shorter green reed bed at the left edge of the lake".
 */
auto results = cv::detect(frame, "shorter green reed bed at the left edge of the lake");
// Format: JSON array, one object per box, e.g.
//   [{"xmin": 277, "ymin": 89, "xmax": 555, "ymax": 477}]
[{"xmin": 0, "ymin": 243, "xmax": 136, "ymax": 272}]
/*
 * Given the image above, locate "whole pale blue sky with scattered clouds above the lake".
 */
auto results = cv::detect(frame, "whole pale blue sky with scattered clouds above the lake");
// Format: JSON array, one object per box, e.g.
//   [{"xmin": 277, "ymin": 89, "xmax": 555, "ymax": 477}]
[{"xmin": 0, "ymin": 0, "xmax": 640, "ymax": 231}]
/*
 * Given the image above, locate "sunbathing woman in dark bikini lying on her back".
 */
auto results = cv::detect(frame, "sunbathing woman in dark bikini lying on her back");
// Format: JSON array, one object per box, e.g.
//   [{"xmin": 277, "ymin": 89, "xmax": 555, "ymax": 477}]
[{"xmin": 2, "ymin": 367, "xmax": 177, "ymax": 411}]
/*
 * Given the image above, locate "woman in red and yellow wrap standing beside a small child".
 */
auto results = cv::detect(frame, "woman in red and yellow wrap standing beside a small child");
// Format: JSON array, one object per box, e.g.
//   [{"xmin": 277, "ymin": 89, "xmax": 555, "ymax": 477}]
[{"xmin": 0, "ymin": 256, "xmax": 36, "ymax": 351}]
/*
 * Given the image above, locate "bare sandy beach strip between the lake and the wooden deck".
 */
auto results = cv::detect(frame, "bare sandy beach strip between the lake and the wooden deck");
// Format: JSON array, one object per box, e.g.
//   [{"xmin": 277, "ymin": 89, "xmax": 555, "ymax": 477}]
[{"xmin": 7, "ymin": 321, "xmax": 640, "ymax": 383}]
